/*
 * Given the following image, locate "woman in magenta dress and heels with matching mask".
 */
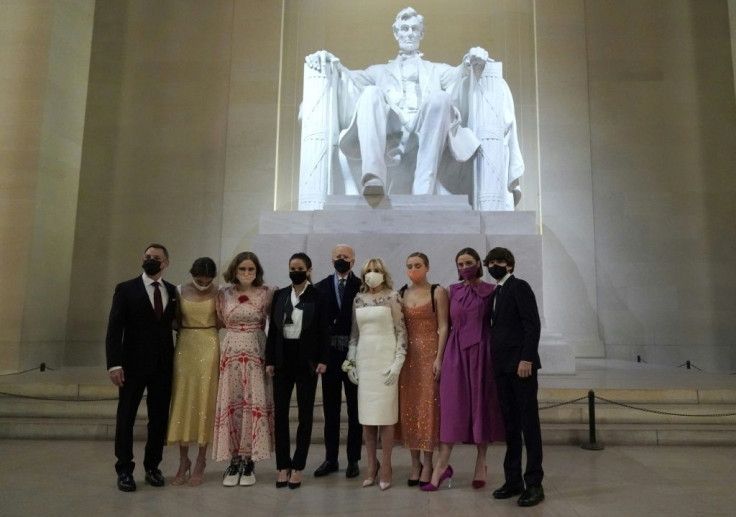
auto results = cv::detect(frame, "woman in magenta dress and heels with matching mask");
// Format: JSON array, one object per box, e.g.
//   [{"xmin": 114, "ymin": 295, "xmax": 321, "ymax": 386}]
[{"xmin": 422, "ymin": 248, "xmax": 505, "ymax": 491}]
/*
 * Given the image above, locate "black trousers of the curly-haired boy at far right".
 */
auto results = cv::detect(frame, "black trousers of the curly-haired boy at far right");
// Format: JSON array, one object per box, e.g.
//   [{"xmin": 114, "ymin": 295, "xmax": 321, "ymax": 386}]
[{"xmin": 496, "ymin": 371, "xmax": 544, "ymax": 487}]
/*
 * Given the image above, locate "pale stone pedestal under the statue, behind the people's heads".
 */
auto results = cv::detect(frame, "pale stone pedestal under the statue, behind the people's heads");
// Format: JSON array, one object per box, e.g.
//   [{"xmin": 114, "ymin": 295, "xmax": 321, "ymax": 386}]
[{"xmin": 253, "ymin": 195, "xmax": 575, "ymax": 374}]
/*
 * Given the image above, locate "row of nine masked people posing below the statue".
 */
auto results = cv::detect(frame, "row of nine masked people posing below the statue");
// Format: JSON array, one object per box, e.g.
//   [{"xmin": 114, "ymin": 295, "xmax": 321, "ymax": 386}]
[{"xmin": 106, "ymin": 244, "xmax": 544, "ymax": 506}]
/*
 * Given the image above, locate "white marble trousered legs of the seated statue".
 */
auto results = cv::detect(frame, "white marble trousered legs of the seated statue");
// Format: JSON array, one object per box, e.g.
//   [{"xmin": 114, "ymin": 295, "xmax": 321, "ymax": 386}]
[{"xmin": 355, "ymin": 86, "xmax": 452, "ymax": 195}]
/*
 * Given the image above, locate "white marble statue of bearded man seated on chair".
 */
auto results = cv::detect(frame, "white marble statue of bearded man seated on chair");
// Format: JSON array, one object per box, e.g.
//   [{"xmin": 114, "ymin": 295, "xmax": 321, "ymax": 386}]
[{"xmin": 299, "ymin": 7, "xmax": 524, "ymax": 210}]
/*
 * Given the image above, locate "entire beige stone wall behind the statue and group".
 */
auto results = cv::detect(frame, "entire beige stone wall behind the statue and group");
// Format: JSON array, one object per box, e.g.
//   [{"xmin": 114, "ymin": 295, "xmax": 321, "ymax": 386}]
[{"xmin": 0, "ymin": 0, "xmax": 736, "ymax": 370}]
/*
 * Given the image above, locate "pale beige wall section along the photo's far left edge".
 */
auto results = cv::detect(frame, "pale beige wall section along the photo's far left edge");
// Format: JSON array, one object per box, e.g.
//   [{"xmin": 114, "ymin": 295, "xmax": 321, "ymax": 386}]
[{"xmin": 0, "ymin": 0, "xmax": 95, "ymax": 371}]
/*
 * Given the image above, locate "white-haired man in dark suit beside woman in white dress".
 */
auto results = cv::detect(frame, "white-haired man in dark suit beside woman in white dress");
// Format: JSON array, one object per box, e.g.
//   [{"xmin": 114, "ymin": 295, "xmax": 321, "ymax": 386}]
[{"xmin": 314, "ymin": 244, "xmax": 363, "ymax": 478}]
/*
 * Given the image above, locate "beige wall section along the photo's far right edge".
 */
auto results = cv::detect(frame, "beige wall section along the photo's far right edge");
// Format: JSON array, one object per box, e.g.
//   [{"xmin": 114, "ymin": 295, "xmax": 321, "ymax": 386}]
[{"xmin": 586, "ymin": 0, "xmax": 736, "ymax": 369}]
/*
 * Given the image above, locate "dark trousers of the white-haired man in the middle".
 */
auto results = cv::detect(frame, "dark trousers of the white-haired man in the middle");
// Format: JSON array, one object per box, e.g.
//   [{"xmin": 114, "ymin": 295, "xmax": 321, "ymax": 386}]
[{"xmin": 322, "ymin": 347, "xmax": 363, "ymax": 463}]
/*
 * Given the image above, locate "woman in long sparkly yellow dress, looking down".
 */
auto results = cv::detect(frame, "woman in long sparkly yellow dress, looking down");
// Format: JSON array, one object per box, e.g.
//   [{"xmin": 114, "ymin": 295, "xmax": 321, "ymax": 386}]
[{"xmin": 167, "ymin": 257, "xmax": 220, "ymax": 486}]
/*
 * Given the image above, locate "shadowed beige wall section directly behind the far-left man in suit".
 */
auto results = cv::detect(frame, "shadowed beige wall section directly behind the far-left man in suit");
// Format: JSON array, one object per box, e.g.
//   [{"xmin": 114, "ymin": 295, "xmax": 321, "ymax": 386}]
[{"xmin": 66, "ymin": 0, "xmax": 239, "ymax": 365}]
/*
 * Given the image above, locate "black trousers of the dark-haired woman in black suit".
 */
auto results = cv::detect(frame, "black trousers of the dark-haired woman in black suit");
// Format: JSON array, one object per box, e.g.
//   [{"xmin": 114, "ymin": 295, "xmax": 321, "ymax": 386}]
[{"xmin": 273, "ymin": 339, "xmax": 317, "ymax": 470}]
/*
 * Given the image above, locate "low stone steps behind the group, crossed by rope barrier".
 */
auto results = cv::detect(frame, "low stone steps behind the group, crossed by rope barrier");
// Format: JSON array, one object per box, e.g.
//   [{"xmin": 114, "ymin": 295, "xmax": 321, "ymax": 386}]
[{"xmin": 0, "ymin": 382, "xmax": 736, "ymax": 445}]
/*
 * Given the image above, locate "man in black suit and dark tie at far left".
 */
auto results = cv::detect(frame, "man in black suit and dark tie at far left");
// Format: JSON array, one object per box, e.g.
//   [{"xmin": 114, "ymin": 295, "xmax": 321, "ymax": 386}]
[{"xmin": 105, "ymin": 244, "xmax": 176, "ymax": 492}]
